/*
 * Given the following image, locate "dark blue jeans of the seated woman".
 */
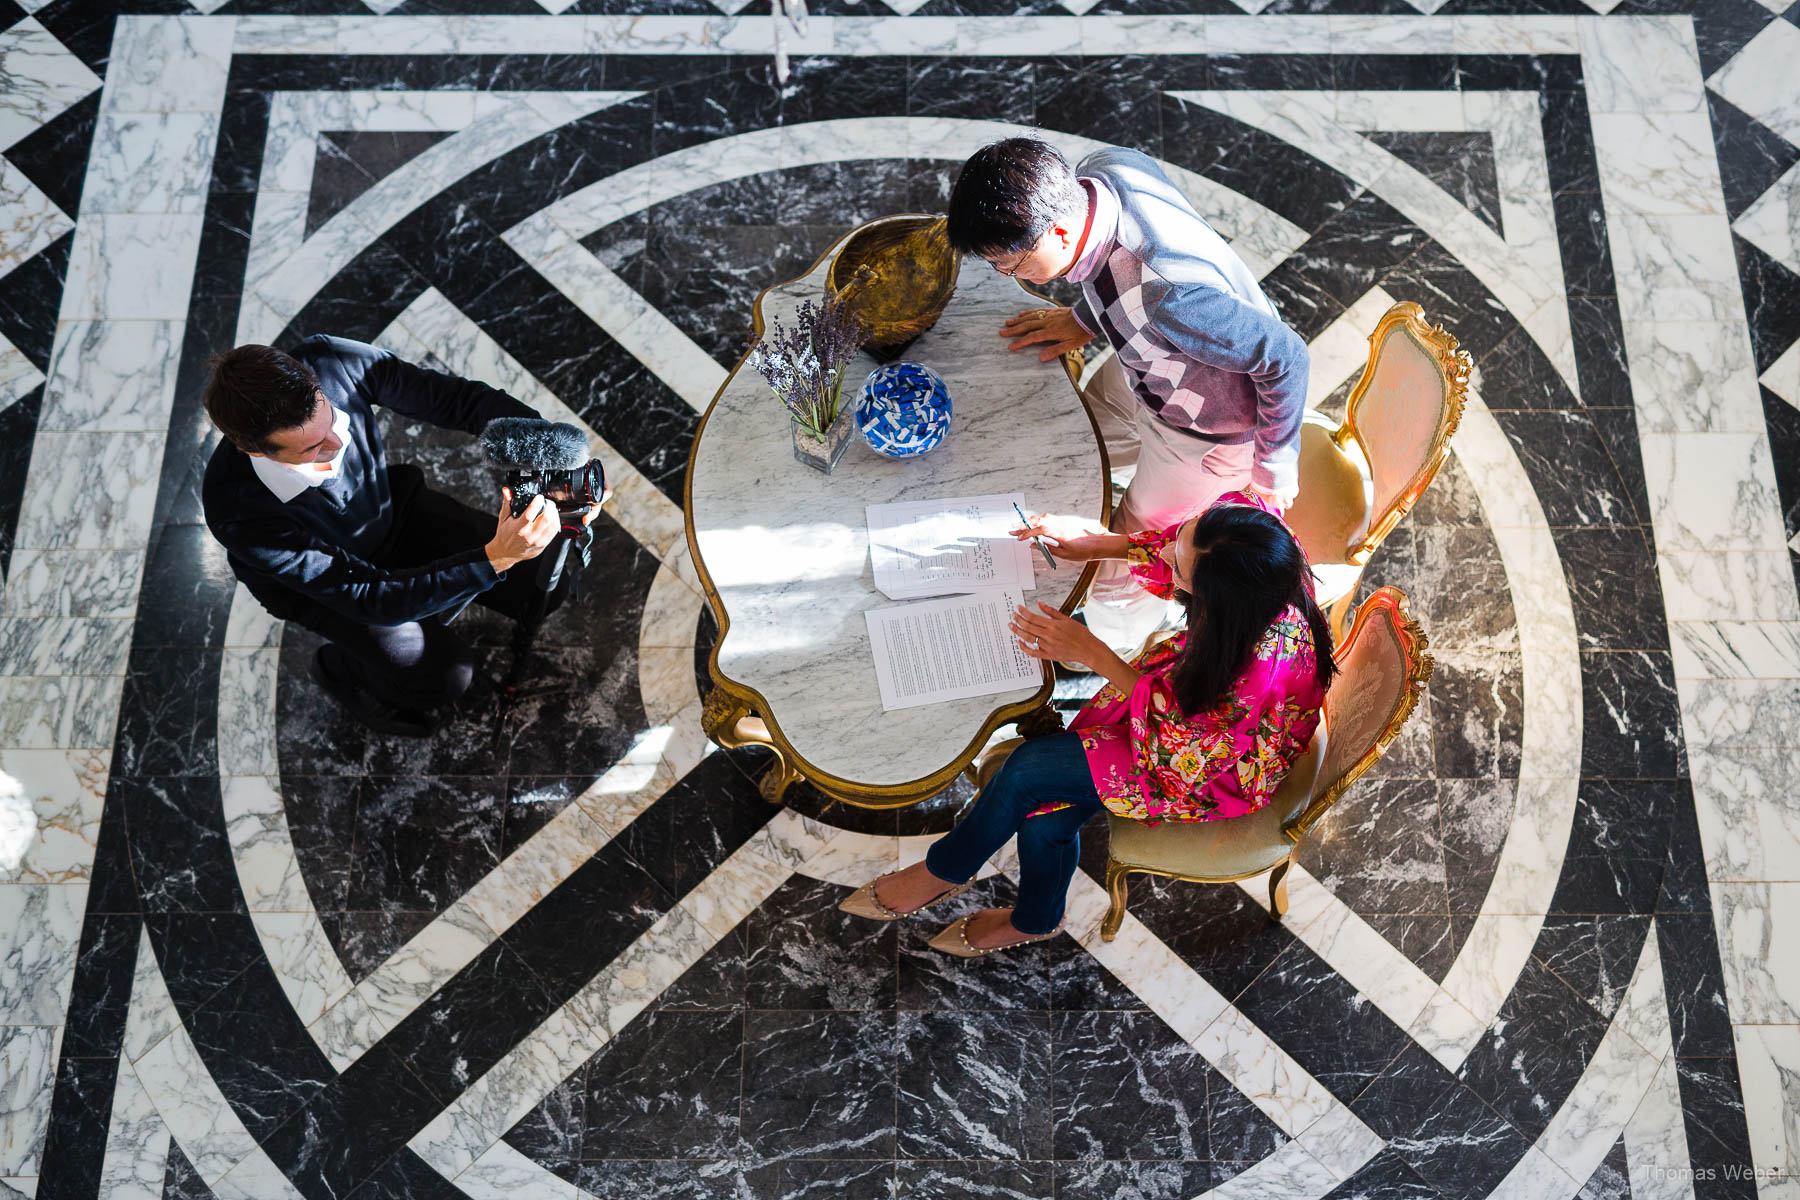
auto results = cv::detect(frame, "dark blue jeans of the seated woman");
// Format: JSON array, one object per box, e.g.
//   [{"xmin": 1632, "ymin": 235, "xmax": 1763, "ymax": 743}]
[{"xmin": 925, "ymin": 734, "xmax": 1105, "ymax": 934}]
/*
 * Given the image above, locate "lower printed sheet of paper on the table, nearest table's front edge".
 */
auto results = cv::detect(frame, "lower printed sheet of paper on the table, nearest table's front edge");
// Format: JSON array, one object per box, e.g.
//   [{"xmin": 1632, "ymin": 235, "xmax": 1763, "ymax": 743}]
[{"xmin": 862, "ymin": 588, "xmax": 1044, "ymax": 711}]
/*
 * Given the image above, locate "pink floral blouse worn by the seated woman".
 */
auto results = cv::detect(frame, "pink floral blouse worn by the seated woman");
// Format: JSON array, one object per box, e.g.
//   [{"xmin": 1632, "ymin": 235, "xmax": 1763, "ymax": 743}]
[{"xmin": 1069, "ymin": 491, "xmax": 1325, "ymax": 824}]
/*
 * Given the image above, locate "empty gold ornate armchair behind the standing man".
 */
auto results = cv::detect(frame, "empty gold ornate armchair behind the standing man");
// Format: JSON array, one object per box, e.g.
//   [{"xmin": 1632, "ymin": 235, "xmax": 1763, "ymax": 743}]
[{"xmin": 1287, "ymin": 302, "xmax": 1471, "ymax": 637}]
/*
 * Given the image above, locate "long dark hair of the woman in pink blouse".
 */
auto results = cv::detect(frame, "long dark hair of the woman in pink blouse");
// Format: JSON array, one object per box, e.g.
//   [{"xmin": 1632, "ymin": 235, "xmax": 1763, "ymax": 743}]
[{"xmin": 1170, "ymin": 504, "xmax": 1337, "ymax": 714}]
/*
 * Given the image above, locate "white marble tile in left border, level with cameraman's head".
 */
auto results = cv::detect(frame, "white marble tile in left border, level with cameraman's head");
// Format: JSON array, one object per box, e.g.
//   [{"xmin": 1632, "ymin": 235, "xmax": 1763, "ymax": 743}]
[{"xmin": 38, "ymin": 320, "xmax": 185, "ymax": 434}]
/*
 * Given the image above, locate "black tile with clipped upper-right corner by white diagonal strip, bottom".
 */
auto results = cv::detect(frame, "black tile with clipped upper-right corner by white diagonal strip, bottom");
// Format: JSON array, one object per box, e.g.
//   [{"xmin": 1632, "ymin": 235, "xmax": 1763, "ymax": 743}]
[{"xmin": 1049, "ymin": 1013, "xmax": 1215, "ymax": 1160}]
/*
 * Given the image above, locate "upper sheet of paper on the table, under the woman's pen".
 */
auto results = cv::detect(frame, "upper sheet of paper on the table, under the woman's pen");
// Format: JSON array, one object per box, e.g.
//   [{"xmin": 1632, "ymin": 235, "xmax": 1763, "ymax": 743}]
[{"xmin": 868, "ymin": 493, "xmax": 1037, "ymax": 599}]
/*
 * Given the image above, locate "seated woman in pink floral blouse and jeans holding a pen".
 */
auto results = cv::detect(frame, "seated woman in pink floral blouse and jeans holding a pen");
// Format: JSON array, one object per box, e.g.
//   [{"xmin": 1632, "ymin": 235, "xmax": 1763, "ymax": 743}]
[{"xmin": 841, "ymin": 493, "xmax": 1336, "ymax": 957}]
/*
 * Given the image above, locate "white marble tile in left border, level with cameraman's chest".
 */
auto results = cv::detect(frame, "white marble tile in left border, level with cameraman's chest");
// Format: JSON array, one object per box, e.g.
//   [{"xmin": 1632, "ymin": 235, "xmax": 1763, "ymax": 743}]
[{"xmin": 14, "ymin": 430, "xmax": 164, "ymax": 551}]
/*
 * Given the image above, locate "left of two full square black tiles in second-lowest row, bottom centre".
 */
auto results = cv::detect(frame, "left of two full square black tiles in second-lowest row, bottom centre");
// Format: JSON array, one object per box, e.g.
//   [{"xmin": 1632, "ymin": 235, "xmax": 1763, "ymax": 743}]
[{"xmin": 743, "ymin": 1009, "xmax": 898, "ymax": 1159}]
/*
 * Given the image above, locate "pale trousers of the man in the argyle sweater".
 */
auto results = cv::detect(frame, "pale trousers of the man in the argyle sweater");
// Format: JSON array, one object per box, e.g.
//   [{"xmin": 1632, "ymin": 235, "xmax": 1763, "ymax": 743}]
[{"xmin": 1082, "ymin": 354, "xmax": 1256, "ymax": 658}]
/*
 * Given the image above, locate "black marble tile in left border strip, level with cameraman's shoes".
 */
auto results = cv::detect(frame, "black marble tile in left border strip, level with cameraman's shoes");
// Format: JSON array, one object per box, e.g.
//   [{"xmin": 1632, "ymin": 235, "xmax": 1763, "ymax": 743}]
[{"xmin": 112, "ymin": 646, "xmax": 220, "ymax": 777}]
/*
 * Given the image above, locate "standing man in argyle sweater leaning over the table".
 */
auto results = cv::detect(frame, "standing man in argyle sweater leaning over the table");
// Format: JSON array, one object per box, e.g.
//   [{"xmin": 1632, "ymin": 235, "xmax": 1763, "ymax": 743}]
[{"xmin": 949, "ymin": 137, "xmax": 1307, "ymax": 646}]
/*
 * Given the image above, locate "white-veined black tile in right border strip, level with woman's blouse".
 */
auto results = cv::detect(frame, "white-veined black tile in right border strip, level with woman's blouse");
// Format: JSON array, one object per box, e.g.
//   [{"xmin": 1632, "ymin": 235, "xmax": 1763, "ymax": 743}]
[{"xmin": 1580, "ymin": 651, "xmax": 1685, "ymax": 779}]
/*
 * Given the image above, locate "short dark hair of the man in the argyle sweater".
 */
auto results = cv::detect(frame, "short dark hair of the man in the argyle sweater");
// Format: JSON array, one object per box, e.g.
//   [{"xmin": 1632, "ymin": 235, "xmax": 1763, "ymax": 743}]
[{"xmin": 947, "ymin": 137, "xmax": 1087, "ymax": 257}]
